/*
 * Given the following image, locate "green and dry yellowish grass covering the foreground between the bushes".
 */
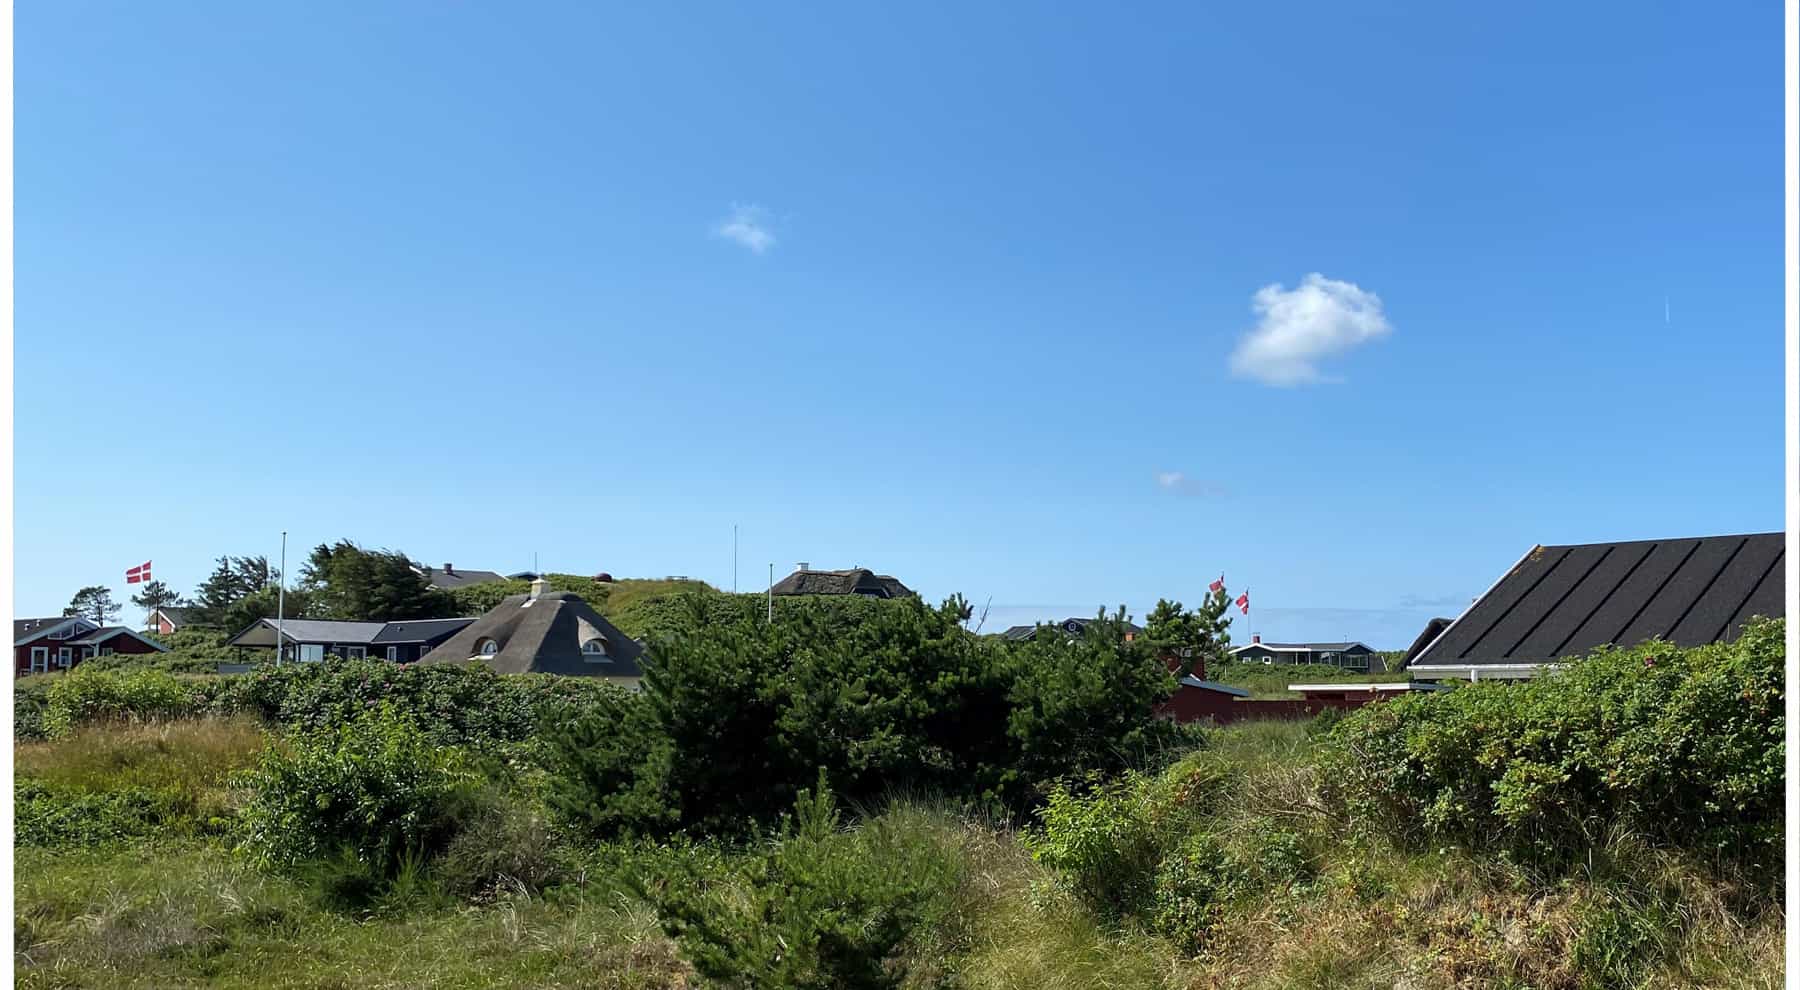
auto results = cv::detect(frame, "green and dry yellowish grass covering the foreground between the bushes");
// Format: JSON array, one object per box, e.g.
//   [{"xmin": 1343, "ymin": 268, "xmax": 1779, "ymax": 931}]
[{"xmin": 14, "ymin": 722, "xmax": 1784, "ymax": 990}]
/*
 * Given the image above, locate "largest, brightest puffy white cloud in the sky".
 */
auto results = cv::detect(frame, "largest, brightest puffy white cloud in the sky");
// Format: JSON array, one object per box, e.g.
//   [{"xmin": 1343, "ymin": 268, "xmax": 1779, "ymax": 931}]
[{"xmin": 1231, "ymin": 272, "xmax": 1393, "ymax": 385}]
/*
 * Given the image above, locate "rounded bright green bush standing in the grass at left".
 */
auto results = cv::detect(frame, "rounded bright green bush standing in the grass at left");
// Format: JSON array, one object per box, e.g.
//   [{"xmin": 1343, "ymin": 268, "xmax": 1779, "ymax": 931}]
[{"xmin": 239, "ymin": 706, "xmax": 481, "ymax": 875}]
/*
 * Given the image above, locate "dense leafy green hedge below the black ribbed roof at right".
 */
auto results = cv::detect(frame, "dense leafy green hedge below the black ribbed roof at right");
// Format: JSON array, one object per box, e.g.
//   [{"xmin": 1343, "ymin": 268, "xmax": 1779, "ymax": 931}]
[{"xmin": 1321, "ymin": 621, "xmax": 1786, "ymax": 878}]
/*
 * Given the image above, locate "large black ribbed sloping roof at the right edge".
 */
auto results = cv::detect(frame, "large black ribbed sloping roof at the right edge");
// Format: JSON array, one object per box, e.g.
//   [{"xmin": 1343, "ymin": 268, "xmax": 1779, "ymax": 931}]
[{"xmin": 1411, "ymin": 533, "xmax": 1786, "ymax": 668}]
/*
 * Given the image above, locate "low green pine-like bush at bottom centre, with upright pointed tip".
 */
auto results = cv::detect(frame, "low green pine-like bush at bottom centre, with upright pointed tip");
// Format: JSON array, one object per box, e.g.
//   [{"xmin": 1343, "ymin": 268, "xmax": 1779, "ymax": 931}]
[{"xmin": 639, "ymin": 774, "xmax": 961, "ymax": 990}]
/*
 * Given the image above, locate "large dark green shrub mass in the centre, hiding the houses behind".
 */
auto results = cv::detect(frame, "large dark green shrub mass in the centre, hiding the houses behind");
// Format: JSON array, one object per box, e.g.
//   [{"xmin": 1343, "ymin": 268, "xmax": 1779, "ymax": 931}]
[{"xmin": 554, "ymin": 596, "xmax": 1183, "ymax": 833}]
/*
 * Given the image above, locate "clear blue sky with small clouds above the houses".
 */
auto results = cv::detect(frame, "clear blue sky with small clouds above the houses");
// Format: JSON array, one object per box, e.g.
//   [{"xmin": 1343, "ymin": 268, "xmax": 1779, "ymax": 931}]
[{"xmin": 14, "ymin": 2, "xmax": 1784, "ymax": 648}]
